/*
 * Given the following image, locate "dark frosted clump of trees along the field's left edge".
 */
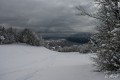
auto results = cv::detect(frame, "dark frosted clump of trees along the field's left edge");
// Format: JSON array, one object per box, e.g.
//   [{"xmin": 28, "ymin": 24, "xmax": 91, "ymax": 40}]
[{"xmin": 0, "ymin": 25, "xmax": 43, "ymax": 46}]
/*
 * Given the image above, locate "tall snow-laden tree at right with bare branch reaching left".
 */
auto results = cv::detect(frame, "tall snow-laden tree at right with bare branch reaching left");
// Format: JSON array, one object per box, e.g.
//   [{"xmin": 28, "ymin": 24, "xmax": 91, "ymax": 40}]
[{"xmin": 78, "ymin": 0, "xmax": 120, "ymax": 71}]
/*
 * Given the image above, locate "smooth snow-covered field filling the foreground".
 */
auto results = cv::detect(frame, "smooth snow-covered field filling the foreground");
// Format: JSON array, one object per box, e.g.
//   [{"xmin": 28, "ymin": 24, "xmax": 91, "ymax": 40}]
[{"xmin": 0, "ymin": 44, "xmax": 120, "ymax": 80}]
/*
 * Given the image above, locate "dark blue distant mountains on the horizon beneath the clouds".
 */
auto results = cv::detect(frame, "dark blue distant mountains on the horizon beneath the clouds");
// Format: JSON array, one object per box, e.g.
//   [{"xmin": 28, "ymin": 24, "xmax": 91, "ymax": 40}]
[{"xmin": 38, "ymin": 32, "xmax": 92, "ymax": 44}]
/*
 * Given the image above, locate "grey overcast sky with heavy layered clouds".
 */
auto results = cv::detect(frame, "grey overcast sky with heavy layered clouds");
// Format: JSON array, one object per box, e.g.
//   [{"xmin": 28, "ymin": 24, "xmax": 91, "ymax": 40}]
[{"xmin": 0, "ymin": 0, "xmax": 95, "ymax": 32}]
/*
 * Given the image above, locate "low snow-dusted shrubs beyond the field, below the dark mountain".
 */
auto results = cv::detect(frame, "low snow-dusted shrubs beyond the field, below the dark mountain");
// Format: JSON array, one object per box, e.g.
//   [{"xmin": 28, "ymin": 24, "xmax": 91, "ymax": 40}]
[{"xmin": 44, "ymin": 39, "xmax": 92, "ymax": 53}]
